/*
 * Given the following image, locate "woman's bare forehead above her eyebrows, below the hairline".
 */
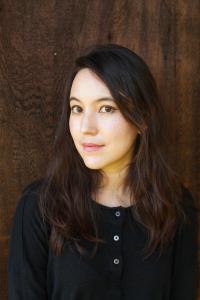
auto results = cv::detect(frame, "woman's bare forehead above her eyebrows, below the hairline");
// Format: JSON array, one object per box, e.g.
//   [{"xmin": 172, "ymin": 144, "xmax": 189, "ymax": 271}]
[{"xmin": 70, "ymin": 68, "xmax": 112, "ymax": 100}]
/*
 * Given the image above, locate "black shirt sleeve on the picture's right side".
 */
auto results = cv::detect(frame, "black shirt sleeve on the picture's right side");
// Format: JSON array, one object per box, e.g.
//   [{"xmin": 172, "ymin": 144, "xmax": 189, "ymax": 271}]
[{"xmin": 170, "ymin": 187, "xmax": 198, "ymax": 300}]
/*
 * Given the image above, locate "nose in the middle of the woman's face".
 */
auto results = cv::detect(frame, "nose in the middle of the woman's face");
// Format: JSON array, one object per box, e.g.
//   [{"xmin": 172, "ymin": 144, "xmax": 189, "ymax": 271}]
[{"xmin": 80, "ymin": 113, "xmax": 97, "ymax": 134}]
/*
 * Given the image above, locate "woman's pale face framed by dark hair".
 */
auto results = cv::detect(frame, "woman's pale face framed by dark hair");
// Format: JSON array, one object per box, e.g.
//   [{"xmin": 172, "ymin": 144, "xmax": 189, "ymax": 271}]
[{"xmin": 69, "ymin": 68, "xmax": 138, "ymax": 172}]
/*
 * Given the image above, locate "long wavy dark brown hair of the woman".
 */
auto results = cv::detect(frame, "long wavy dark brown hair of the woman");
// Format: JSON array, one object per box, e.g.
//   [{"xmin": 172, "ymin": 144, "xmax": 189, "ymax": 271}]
[{"xmin": 39, "ymin": 44, "xmax": 186, "ymax": 258}]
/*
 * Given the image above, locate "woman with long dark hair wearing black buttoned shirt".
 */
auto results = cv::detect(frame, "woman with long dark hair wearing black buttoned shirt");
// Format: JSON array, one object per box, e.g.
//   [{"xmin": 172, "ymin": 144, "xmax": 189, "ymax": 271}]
[{"xmin": 8, "ymin": 44, "xmax": 197, "ymax": 300}]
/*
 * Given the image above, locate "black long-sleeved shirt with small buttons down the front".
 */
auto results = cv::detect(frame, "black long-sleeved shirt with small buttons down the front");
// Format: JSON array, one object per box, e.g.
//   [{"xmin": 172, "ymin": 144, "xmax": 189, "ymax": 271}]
[{"xmin": 8, "ymin": 181, "xmax": 197, "ymax": 300}]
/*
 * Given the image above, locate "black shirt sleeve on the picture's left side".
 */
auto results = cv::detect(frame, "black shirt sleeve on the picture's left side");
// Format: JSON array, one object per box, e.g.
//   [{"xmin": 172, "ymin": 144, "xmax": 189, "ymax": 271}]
[{"xmin": 8, "ymin": 182, "xmax": 48, "ymax": 300}]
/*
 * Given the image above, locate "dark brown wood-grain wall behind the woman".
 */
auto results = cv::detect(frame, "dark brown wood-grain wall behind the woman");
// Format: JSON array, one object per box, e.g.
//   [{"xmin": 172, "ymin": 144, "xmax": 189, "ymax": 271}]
[{"xmin": 0, "ymin": 0, "xmax": 200, "ymax": 300}]
